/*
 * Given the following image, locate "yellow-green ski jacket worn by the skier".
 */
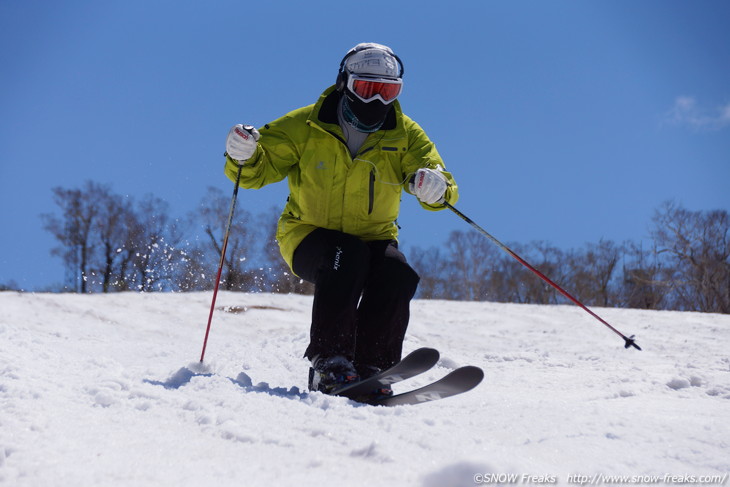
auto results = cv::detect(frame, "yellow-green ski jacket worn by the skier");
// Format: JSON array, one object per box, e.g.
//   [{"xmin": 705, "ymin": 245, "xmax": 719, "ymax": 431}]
[{"xmin": 225, "ymin": 86, "xmax": 458, "ymax": 267}]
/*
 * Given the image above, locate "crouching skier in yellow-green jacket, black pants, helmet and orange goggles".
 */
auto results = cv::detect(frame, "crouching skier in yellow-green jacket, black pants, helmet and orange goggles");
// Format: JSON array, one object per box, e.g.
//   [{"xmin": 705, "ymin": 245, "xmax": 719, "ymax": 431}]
[{"xmin": 225, "ymin": 43, "xmax": 458, "ymax": 395}]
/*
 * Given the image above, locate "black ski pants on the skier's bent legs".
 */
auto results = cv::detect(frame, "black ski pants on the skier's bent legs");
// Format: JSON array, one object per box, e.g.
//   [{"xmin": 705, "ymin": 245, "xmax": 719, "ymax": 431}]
[{"xmin": 292, "ymin": 228, "xmax": 419, "ymax": 369}]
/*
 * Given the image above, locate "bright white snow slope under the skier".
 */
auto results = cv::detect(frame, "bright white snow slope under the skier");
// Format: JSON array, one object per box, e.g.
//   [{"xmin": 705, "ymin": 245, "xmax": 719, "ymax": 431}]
[{"xmin": 0, "ymin": 292, "xmax": 730, "ymax": 487}]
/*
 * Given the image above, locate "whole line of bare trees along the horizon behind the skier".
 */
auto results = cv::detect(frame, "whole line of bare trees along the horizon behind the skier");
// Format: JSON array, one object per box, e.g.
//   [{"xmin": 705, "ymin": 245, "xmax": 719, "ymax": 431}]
[{"xmin": 41, "ymin": 181, "xmax": 730, "ymax": 313}]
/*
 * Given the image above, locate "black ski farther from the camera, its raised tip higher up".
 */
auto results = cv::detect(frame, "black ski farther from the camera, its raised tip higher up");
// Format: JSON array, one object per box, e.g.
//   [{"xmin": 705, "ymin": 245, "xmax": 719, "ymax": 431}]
[{"xmin": 332, "ymin": 348, "xmax": 439, "ymax": 400}]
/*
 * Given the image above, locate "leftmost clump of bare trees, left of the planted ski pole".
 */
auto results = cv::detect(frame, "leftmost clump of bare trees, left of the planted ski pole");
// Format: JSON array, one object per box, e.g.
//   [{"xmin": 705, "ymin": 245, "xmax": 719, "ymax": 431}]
[{"xmin": 42, "ymin": 181, "xmax": 186, "ymax": 293}]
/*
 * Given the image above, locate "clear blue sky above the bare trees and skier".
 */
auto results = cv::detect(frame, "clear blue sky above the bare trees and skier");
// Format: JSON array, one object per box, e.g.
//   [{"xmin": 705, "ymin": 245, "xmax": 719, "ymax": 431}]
[{"xmin": 0, "ymin": 0, "xmax": 730, "ymax": 290}]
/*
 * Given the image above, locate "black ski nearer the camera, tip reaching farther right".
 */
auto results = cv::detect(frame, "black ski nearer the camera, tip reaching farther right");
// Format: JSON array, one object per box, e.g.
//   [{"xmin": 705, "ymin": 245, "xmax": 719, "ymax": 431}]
[{"xmin": 368, "ymin": 365, "xmax": 484, "ymax": 406}]
